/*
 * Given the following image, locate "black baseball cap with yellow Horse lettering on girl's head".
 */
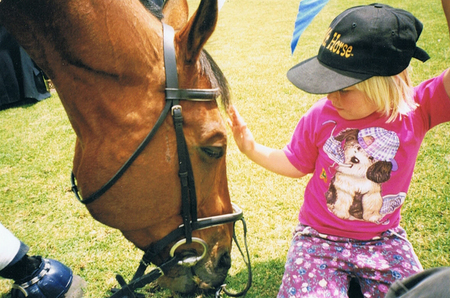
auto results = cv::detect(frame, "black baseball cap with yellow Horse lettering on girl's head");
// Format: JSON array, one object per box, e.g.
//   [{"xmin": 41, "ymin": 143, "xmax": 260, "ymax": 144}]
[{"xmin": 287, "ymin": 3, "xmax": 430, "ymax": 94}]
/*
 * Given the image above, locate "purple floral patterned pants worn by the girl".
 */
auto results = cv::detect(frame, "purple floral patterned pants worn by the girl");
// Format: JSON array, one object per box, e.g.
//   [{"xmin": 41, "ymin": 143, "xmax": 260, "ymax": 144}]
[{"xmin": 277, "ymin": 224, "xmax": 423, "ymax": 298}]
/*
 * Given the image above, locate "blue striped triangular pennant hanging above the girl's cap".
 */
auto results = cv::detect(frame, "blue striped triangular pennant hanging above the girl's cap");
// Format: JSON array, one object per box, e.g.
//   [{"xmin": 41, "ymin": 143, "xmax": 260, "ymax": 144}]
[{"xmin": 291, "ymin": 0, "xmax": 329, "ymax": 53}]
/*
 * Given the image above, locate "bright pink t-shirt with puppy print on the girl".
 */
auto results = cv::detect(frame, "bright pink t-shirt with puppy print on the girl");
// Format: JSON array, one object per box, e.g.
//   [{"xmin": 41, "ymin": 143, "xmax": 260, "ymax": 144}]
[{"xmin": 283, "ymin": 74, "xmax": 450, "ymax": 240}]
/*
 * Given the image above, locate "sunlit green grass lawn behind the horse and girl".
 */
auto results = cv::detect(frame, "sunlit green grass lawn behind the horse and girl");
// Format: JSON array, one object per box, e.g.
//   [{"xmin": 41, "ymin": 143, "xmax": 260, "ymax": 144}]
[{"xmin": 0, "ymin": 0, "xmax": 450, "ymax": 298}]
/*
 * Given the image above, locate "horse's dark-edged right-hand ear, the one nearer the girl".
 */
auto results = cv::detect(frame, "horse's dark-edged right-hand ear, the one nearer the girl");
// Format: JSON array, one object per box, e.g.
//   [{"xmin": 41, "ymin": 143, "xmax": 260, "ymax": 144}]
[{"xmin": 177, "ymin": 0, "xmax": 218, "ymax": 62}]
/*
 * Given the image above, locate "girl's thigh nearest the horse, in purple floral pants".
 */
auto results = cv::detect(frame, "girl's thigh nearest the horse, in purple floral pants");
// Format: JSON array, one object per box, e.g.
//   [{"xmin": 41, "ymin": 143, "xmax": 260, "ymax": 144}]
[{"xmin": 277, "ymin": 225, "xmax": 350, "ymax": 298}]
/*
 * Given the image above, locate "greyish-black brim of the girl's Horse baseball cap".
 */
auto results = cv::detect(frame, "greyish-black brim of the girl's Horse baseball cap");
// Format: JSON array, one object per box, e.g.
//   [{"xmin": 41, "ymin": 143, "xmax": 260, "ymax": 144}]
[{"xmin": 287, "ymin": 56, "xmax": 373, "ymax": 94}]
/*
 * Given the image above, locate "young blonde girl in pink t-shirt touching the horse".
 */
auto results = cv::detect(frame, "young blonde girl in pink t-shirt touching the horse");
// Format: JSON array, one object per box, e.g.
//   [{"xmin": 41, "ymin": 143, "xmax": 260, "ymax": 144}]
[{"xmin": 229, "ymin": 1, "xmax": 450, "ymax": 298}]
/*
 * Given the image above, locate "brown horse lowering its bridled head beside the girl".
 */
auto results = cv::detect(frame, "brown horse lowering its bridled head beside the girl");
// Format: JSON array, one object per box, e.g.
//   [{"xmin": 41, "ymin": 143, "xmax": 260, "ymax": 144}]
[{"xmin": 0, "ymin": 0, "xmax": 239, "ymax": 292}]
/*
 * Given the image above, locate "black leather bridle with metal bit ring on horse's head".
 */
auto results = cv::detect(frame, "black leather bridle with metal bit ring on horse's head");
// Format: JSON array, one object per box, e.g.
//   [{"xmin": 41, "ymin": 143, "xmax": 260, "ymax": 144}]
[{"xmin": 71, "ymin": 23, "xmax": 252, "ymax": 298}]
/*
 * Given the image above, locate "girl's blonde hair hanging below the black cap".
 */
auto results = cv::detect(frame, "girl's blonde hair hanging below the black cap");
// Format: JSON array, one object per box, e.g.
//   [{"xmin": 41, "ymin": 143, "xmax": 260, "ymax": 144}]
[{"xmin": 354, "ymin": 69, "xmax": 418, "ymax": 122}]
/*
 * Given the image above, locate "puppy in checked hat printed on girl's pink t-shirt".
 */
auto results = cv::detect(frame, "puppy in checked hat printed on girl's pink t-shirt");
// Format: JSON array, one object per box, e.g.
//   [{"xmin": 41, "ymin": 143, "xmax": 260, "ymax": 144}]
[{"xmin": 324, "ymin": 127, "xmax": 399, "ymax": 223}]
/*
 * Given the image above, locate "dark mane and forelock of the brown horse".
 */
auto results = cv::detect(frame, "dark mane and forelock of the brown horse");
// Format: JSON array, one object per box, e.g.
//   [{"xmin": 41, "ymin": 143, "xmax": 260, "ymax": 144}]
[{"xmin": 140, "ymin": 0, "xmax": 231, "ymax": 111}]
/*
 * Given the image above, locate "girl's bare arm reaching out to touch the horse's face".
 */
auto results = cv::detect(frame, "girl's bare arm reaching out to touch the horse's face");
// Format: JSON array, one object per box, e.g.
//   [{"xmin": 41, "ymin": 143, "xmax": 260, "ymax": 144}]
[{"xmin": 228, "ymin": 106, "xmax": 306, "ymax": 178}]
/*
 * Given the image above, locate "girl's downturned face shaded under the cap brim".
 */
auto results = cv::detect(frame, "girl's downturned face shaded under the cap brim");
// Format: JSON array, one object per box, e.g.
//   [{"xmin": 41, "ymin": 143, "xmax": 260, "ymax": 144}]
[{"xmin": 327, "ymin": 87, "xmax": 378, "ymax": 120}]
